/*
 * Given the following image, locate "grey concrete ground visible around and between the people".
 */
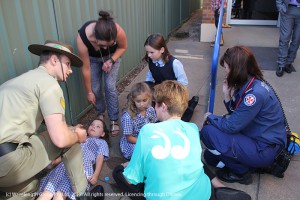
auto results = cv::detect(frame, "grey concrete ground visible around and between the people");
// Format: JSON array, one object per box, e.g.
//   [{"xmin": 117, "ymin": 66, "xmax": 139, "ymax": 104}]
[{"xmin": 100, "ymin": 12, "xmax": 300, "ymax": 200}]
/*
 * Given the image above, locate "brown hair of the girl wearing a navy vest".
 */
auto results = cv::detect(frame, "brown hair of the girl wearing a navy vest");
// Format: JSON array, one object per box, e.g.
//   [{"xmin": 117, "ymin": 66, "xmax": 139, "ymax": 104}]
[{"xmin": 143, "ymin": 33, "xmax": 171, "ymax": 63}]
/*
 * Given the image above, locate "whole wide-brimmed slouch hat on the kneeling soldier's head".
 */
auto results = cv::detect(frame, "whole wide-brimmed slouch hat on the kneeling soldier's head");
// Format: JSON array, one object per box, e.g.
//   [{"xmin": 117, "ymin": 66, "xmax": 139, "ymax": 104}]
[{"xmin": 28, "ymin": 40, "xmax": 83, "ymax": 67}]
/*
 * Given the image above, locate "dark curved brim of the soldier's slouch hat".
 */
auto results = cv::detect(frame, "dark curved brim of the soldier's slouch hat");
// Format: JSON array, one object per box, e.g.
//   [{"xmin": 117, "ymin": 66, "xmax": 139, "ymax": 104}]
[{"xmin": 28, "ymin": 44, "xmax": 83, "ymax": 67}]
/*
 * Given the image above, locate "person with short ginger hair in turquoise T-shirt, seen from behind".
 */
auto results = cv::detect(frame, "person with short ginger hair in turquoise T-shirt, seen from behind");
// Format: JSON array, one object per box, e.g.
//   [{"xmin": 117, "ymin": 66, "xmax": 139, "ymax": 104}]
[{"xmin": 113, "ymin": 81, "xmax": 251, "ymax": 200}]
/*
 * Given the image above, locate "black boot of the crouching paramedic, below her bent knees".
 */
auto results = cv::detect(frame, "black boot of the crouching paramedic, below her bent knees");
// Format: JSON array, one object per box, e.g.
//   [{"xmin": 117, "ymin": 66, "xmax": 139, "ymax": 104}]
[{"xmin": 217, "ymin": 168, "xmax": 253, "ymax": 185}]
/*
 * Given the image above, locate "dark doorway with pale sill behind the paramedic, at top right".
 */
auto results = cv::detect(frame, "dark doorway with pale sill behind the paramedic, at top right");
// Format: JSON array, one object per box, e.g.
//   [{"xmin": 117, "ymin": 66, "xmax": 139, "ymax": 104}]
[{"xmin": 227, "ymin": 0, "xmax": 278, "ymax": 25}]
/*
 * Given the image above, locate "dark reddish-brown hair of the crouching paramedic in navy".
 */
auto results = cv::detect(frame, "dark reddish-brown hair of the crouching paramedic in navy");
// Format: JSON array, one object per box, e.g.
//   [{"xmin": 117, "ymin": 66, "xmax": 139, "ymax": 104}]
[{"xmin": 220, "ymin": 46, "xmax": 264, "ymax": 90}]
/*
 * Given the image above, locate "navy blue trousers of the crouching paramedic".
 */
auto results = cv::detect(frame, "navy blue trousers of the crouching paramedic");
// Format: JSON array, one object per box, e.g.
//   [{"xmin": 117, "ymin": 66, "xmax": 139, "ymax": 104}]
[{"xmin": 200, "ymin": 125, "xmax": 280, "ymax": 174}]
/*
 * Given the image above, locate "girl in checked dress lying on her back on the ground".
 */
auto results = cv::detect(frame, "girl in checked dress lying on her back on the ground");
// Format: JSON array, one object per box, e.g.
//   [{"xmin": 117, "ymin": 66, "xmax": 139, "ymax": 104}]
[{"xmin": 38, "ymin": 119, "xmax": 109, "ymax": 200}]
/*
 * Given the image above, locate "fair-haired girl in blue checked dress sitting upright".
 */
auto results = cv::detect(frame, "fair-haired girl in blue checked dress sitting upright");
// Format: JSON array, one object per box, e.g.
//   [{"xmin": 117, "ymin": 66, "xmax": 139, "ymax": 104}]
[{"xmin": 120, "ymin": 82, "xmax": 157, "ymax": 160}]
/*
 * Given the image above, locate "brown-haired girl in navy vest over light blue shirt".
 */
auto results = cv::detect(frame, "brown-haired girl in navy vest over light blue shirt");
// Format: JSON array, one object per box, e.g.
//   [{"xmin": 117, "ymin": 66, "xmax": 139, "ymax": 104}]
[{"xmin": 144, "ymin": 33, "xmax": 199, "ymax": 122}]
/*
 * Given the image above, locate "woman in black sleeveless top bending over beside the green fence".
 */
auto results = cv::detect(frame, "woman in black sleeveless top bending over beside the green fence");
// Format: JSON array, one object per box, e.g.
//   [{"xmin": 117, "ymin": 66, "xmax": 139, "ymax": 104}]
[{"xmin": 77, "ymin": 11, "xmax": 127, "ymax": 136}]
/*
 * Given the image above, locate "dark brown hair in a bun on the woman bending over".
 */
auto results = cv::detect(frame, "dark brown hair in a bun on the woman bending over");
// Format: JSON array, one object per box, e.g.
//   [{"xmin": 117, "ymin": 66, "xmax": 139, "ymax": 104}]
[{"xmin": 95, "ymin": 10, "xmax": 117, "ymax": 42}]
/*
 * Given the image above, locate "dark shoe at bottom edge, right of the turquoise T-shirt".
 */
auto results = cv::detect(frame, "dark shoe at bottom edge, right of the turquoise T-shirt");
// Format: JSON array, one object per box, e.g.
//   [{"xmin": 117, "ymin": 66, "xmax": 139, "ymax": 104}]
[{"xmin": 214, "ymin": 187, "xmax": 251, "ymax": 200}]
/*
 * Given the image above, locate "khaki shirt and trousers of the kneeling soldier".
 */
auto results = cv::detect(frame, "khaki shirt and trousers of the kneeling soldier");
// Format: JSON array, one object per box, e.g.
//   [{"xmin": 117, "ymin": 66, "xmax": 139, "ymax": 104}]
[{"xmin": 0, "ymin": 66, "xmax": 87, "ymax": 199}]
